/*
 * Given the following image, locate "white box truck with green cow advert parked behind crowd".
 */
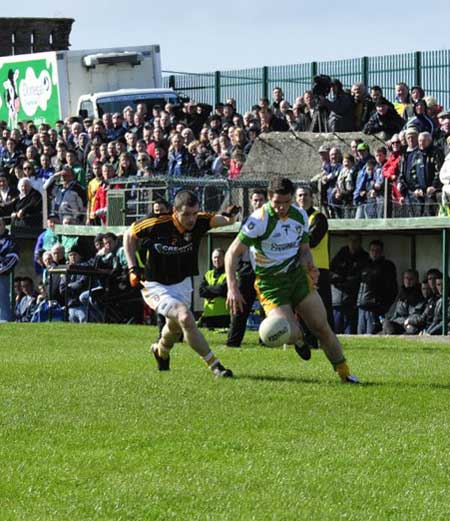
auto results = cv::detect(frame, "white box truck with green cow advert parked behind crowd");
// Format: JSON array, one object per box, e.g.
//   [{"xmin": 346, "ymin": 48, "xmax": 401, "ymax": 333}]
[{"xmin": 0, "ymin": 45, "xmax": 178, "ymax": 128}]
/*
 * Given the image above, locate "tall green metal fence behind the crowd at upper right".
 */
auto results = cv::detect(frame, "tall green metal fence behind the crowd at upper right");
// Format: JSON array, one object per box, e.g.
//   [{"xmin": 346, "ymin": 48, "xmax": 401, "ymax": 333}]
[{"xmin": 164, "ymin": 50, "xmax": 450, "ymax": 113}]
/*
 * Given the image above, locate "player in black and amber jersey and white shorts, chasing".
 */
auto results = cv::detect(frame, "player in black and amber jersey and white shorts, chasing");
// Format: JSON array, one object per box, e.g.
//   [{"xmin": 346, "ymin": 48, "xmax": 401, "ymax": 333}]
[{"xmin": 124, "ymin": 190, "xmax": 240, "ymax": 377}]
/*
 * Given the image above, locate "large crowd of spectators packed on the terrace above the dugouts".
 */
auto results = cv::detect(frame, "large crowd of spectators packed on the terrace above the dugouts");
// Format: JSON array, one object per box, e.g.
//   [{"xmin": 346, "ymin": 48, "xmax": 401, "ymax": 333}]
[{"xmin": 0, "ymin": 80, "xmax": 450, "ymax": 228}]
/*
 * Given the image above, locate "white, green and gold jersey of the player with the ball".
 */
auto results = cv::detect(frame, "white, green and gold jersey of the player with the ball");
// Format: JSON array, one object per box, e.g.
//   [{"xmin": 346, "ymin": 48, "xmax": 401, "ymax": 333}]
[{"xmin": 239, "ymin": 202, "xmax": 309, "ymax": 276}]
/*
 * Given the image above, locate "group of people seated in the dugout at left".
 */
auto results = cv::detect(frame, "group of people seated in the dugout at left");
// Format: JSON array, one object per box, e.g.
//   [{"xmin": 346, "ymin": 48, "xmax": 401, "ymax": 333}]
[{"xmin": 14, "ymin": 225, "xmax": 144, "ymax": 323}]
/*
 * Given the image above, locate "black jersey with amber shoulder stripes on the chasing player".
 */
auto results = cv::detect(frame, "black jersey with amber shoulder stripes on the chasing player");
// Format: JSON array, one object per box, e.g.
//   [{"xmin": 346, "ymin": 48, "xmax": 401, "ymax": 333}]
[{"xmin": 130, "ymin": 212, "xmax": 213, "ymax": 285}]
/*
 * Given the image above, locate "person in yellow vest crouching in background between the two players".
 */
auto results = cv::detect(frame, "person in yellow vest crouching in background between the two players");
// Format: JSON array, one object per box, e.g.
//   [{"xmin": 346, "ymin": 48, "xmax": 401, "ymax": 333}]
[{"xmin": 199, "ymin": 248, "xmax": 230, "ymax": 329}]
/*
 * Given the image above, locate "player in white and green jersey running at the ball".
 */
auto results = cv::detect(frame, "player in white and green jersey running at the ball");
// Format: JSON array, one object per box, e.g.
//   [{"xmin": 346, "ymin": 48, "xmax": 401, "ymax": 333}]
[{"xmin": 225, "ymin": 177, "xmax": 358, "ymax": 383}]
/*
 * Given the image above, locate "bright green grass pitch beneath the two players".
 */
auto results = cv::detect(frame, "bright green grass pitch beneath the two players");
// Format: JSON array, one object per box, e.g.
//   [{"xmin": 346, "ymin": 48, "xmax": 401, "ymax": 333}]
[{"xmin": 0, "ymin": 324, "xmax": 450, "ymax": 521}]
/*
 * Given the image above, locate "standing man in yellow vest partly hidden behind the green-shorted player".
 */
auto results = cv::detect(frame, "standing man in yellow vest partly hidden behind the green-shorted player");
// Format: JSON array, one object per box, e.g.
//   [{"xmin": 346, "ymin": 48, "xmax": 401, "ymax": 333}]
[{"xmin": 295, "ymin": 186, "xmax": 334, "ymax": 358}]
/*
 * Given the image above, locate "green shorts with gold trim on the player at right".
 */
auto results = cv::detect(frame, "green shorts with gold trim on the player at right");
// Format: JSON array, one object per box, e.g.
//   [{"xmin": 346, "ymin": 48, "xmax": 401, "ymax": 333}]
[{"xmin": 255, "ymin": 266, "xmax": 314, "ymax": 315}]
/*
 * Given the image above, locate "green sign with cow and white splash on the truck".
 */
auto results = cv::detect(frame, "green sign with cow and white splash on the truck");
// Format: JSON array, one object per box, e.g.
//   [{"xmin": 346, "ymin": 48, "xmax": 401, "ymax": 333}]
[{"xmin": 0, "ymin": 54, "xmax": 60, "ymax": 128}]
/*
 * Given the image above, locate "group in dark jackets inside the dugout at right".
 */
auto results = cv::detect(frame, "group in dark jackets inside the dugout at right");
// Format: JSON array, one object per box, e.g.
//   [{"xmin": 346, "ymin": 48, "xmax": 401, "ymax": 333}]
[{"xmin": 330, "ymin": 234, "xmax": 450, "ymax": 335}]
